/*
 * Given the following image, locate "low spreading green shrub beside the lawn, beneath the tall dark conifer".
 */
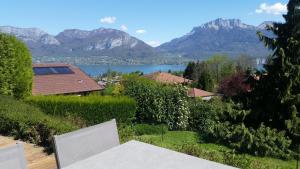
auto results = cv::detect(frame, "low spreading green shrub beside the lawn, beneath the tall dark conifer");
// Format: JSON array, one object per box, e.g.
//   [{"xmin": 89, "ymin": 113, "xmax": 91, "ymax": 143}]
[{"xmin": 212, "ymin": 123, "xmax": 293, "ymax": 159}]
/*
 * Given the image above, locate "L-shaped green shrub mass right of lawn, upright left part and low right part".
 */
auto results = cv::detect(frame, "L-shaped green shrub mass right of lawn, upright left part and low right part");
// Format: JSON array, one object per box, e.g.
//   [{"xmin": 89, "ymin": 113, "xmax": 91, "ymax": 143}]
[{"xmin": 210, "ymin": 100, "xmax": 292, "ymax": 159}]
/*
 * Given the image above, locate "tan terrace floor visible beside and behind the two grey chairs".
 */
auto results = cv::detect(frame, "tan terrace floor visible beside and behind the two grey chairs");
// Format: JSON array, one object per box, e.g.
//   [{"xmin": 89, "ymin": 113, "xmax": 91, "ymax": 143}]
[{"xmin": 0, "ymin": 135, "xmax": 56, "ymax": 169}]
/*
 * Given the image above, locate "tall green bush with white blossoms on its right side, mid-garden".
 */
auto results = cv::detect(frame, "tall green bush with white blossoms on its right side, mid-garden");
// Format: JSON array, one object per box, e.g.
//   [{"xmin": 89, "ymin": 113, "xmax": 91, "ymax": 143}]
[{"xmin": 122, "ymin": 75, "xmax": 189, "ymax": 129}]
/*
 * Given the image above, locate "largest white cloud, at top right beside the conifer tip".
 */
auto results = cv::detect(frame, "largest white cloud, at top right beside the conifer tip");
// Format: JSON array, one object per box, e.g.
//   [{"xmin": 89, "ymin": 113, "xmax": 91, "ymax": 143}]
[{"xmin": 255, "ymin": 2, "xmax": 287, "ymax": 15}]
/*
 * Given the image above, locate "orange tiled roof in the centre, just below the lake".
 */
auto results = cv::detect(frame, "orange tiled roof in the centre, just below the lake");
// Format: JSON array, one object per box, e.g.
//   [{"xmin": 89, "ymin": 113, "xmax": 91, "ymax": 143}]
[{"xmin": 144, "ymin": 72, "xmax": 192, "ymax": 84}]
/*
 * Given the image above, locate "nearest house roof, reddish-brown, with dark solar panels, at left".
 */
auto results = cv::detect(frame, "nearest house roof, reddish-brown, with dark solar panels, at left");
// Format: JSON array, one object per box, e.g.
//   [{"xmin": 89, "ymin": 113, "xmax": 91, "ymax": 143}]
[{"xmin": 32, "ymin": 64, "xmax": 103, "ymax": 95}]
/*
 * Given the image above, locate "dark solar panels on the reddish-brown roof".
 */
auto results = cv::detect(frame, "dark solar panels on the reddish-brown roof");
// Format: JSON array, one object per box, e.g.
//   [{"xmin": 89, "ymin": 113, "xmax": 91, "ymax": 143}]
[{"xmin": 33, "ymin": 66, "xmax": 74, "ymax": 75}]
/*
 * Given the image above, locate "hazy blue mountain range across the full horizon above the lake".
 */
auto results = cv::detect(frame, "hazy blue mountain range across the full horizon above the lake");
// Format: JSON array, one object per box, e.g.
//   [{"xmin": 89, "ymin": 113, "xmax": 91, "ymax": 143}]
[{"xmin": 0, "ymin": 19, "xmax": 270, "ymax": 64}]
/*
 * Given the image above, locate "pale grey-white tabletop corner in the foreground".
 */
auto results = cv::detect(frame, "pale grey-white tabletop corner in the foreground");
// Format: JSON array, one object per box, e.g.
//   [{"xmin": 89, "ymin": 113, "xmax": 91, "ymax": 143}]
[{"xmin": 64, "ymin": 141, "xmax": 234, "ymax": 169}]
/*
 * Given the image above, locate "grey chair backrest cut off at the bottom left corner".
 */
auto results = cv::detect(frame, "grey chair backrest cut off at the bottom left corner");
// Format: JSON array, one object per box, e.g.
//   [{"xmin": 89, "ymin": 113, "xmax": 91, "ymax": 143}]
[{"xmin": 0, "ymin": 143, "xmax": 27, "ymax": 169}]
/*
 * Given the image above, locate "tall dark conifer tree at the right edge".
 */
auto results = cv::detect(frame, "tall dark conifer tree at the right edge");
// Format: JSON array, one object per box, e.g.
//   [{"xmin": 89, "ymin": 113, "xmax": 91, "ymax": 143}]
[{"xmin": 249, "ymin": 0, "xmax": 300, "ymax": 144}]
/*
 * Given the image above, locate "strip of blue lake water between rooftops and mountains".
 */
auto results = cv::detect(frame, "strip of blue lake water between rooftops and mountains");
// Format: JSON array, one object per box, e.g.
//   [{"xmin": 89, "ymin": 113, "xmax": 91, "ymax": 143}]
[{"xmin": 77, "ymin": 65, "xmax": 186, "ymax": 76}]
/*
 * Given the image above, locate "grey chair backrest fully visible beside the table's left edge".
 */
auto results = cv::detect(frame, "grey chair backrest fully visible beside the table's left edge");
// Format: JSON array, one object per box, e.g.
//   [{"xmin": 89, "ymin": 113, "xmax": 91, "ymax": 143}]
[{"xmin": 54, "ymin": 119, "xmax": 120, "ymax": 169}]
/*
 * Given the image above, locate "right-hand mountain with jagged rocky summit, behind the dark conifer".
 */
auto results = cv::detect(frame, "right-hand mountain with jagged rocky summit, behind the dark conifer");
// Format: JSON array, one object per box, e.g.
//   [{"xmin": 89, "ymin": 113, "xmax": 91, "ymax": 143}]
[{"xmin": 157, "ymin": 18, "xmax": 271, "ymax": 59}]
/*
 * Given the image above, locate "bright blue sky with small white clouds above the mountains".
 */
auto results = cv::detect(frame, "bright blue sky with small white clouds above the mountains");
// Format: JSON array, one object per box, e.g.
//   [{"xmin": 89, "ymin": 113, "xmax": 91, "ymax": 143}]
[{"xmin": 0, "ymin": 0, "xmax": 288, "ymax": 46}]
